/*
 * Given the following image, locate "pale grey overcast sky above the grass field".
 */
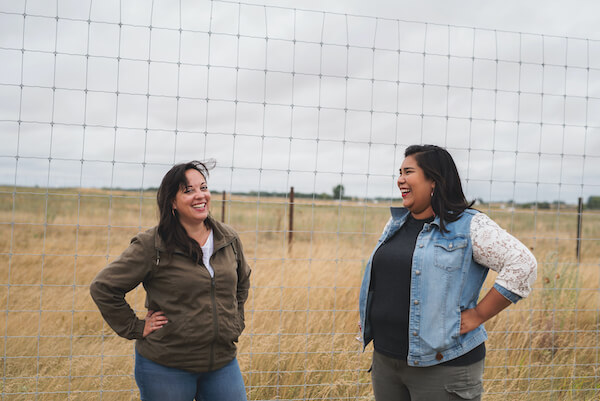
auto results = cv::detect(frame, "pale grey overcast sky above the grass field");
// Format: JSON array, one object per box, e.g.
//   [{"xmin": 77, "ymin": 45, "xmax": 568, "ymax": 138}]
[{"xmin": 0, "ymin": 0, "xmax": 600, "ymax": 202}]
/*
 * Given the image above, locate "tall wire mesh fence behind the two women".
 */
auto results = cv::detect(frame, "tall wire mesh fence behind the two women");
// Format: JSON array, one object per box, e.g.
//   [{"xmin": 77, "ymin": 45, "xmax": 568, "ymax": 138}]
[{"xmin": 0, "ymin": 0, "xmax": 600, "ymax": 400}]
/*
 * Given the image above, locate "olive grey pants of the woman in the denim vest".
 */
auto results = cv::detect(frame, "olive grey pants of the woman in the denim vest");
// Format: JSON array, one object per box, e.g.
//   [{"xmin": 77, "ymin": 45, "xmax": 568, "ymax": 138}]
[{"xmin": 371, "ymin": 351, "xmax": 484, "ymax": 401}]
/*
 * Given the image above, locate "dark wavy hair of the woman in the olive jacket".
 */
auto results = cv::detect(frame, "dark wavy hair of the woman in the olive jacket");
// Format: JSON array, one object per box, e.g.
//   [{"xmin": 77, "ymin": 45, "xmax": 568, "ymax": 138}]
[{"xmin": 156, "ymin": 160, "xmax": 215, "ymax": 263}]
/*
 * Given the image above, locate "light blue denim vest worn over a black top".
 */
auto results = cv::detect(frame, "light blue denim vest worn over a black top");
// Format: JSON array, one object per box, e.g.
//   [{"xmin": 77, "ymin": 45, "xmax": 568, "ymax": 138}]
[{"xmin": 359, "ymin": 208, "xmax": 520, "ymax": 366}]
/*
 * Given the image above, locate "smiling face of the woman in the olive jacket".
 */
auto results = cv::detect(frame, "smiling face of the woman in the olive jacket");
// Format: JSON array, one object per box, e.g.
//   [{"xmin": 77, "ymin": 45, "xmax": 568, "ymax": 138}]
[{"xmin": 173, "ymin": 169, "xmax": 210, "ymax": 231}]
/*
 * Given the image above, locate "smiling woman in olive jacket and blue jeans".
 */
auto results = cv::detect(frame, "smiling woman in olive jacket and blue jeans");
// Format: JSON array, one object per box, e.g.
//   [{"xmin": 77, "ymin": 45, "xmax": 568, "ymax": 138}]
[{"xmin": 90, "ymin": 161, "xmax": 250, "ymax": 401}]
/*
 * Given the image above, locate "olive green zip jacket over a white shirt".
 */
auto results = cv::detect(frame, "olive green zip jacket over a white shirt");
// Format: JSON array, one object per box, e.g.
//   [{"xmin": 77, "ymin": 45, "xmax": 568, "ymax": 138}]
[{"xmin": 90, "ymin": 217, "xmax": 250, "ymax": 372}]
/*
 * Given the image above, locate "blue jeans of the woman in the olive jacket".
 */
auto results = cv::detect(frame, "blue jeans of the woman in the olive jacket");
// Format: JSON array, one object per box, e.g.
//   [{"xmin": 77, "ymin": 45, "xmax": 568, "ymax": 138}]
[{"xmin": 135, "ymin": 350, "xmax": 246, "ymax": 401}]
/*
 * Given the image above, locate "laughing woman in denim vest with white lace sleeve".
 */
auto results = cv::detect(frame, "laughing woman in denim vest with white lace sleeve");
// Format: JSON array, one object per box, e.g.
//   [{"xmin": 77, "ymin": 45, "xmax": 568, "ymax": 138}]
[{"xmin": 359, "ymin": 145, "xmax": 537, "ymax": 401}]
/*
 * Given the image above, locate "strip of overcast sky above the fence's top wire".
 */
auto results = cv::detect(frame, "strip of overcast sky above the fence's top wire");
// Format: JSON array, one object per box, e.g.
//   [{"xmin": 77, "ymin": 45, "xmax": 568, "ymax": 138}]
[{"xmin": 246, "ymin": 0, "xmax": 600, "ymax": 39}]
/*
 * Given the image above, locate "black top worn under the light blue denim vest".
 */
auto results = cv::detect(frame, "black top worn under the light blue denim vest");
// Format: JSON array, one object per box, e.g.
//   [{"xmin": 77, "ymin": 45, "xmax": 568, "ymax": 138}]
[{"xmin": 369, "ymin": 214, "xmax": 485, "ymax": 366}]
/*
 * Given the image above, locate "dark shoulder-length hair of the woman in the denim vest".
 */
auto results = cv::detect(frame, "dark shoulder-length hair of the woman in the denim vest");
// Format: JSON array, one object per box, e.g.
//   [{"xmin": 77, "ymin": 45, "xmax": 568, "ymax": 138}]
[{"xmin": 404, "ymin": 145, "xmax": 475, "ymax": 232}]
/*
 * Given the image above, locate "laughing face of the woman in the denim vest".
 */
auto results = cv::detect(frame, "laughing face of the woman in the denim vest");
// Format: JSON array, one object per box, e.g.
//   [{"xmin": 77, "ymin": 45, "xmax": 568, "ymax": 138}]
[{"xmin": 398, "ymin": 155, "xmax": 435, "ymax": 219}]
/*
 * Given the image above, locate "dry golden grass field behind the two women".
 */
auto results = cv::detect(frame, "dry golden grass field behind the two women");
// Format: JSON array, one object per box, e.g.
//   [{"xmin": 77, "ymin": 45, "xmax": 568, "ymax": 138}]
[{"xmin": 0, "ymin": 187, "xmax": 600, "ymax": 401}]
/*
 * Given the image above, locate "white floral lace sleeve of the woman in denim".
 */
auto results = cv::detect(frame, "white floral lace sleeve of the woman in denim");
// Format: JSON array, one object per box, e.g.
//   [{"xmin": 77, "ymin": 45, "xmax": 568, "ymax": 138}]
[{"xmin": 471, "ymin": 213, "xmax": 537, "ymax": 298}]
